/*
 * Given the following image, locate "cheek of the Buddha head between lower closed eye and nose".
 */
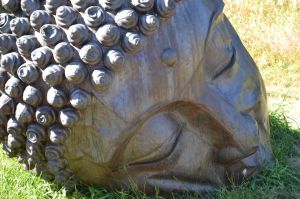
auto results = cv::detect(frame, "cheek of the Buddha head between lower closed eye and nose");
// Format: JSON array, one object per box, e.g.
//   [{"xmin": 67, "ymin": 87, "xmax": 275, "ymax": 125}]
[{"xmin": 171, "ymin": 126, "xmax": 224, "ymax": 184}]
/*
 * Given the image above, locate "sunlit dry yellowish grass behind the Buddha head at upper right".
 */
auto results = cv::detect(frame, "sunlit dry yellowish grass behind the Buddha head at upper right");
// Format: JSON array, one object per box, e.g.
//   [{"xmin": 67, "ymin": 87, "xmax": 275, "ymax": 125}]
[{"xmin": 224, "ymin": 0, "xmax": 300, "ymax": 127}]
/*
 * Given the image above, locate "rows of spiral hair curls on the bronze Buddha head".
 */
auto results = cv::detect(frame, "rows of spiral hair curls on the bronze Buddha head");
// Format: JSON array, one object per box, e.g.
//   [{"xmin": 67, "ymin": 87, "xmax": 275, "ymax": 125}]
[{"xmin": 0, "ymin": 0, "xmax": 183, "ymax": 191}]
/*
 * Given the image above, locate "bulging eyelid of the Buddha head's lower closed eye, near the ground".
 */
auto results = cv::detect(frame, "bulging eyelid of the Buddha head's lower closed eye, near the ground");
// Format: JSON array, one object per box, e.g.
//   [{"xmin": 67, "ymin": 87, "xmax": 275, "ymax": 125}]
[{"xmin": 120, "ymin": 112, "xmax": 185, "ymax": 167}]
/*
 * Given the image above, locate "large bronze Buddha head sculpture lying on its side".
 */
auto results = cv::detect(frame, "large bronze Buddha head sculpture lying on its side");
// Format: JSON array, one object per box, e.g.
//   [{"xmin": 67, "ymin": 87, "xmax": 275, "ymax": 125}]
[{"xmin": 0, "ymin": 0, "xmax": 272, "ymax": 192}]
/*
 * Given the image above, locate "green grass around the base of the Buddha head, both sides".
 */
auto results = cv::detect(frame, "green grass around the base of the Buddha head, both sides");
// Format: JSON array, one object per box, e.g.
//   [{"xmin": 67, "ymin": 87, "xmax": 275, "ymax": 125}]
[{"xmin": 0, "ymin": 113, "xmax": 300, "ymax": 199}]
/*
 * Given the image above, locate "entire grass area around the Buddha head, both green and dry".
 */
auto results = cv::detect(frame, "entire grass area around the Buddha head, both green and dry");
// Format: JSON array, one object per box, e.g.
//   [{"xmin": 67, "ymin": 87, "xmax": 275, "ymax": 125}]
[{"xmin": 0, "ymin": 0, "xmax": 300, "ymax": 199}]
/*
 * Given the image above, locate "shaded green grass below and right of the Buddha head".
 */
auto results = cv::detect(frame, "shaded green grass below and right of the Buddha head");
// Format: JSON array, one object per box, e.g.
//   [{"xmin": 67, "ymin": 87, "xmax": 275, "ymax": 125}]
[{"xmin": 65, "ymin": 113, "xmax": 300, "ymax": 199}]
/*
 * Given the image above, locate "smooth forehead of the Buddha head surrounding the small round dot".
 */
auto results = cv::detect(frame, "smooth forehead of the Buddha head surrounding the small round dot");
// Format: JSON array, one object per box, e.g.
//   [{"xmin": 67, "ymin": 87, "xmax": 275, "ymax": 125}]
[{"xmin": 94, "ymin": 0, "xmax": 218, "ymax": 121}]
